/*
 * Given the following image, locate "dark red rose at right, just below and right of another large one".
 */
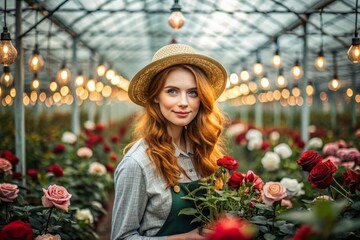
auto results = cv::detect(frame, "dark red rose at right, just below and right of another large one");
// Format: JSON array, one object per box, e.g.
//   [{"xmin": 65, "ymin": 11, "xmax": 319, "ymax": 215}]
[{"xmin": 308, "ymin": 160, "xmax": 336, "ymax": 189}]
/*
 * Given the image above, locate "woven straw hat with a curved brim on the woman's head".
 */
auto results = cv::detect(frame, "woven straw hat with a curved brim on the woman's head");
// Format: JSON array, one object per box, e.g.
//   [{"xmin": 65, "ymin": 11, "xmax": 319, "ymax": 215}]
[{"xmin": 128, "ymin": 44, "xmax": 227, "ymax": 106}]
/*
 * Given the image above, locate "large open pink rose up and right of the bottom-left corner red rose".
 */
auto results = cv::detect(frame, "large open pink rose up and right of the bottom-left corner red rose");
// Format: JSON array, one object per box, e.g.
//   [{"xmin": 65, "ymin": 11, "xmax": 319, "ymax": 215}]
[{"xmin": 41, "ymin": 185, "xmax": 71, "ymax": 212}]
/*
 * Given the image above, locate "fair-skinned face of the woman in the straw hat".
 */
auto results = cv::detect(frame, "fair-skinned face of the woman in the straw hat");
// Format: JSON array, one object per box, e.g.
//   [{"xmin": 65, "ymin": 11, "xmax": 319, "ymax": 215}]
[{"xmin": 155, "ymin": 68, "xmax": 200, "ymax": 130}]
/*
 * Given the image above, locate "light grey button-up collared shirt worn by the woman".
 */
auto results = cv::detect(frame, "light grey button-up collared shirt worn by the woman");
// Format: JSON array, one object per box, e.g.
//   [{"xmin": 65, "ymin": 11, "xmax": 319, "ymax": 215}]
[{"xmin": 111, "ymin": 139, "xmax": 199, "ymax": 240}]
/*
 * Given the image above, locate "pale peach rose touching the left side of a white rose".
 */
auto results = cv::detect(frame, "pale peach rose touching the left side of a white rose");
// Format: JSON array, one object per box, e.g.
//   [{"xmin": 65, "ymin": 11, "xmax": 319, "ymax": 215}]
[{"xmin": 262, "ymin": 182, "xmax": 286, "ymax": 206}]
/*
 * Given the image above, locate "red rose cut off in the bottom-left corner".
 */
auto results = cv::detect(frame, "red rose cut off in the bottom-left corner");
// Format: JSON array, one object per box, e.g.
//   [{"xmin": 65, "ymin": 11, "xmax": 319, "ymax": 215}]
[{"xmin": 0, "ymin": 220, "xmax": 34, "ymax": 240}]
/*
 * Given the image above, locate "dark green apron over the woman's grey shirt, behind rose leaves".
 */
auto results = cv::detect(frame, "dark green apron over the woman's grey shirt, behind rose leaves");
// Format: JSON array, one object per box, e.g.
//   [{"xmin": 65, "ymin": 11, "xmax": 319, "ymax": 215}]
[{"xmin": 156, "ymin": 181, "xmax": 200, "ymax": 236}]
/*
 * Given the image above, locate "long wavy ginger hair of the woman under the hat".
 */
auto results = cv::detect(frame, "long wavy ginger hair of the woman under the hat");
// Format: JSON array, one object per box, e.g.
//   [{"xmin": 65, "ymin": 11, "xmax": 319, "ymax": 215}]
[{"xmin": 124, "ymin": 65, "xmax": 225, "ymax": 187}]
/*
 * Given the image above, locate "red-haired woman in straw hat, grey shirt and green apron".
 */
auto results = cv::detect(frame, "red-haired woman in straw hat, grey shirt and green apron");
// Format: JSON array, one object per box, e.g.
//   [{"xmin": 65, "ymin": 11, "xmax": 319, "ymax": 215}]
[{"xmin": 112, "ymin": 44, "xmax": 227, "ymax": 240}]
